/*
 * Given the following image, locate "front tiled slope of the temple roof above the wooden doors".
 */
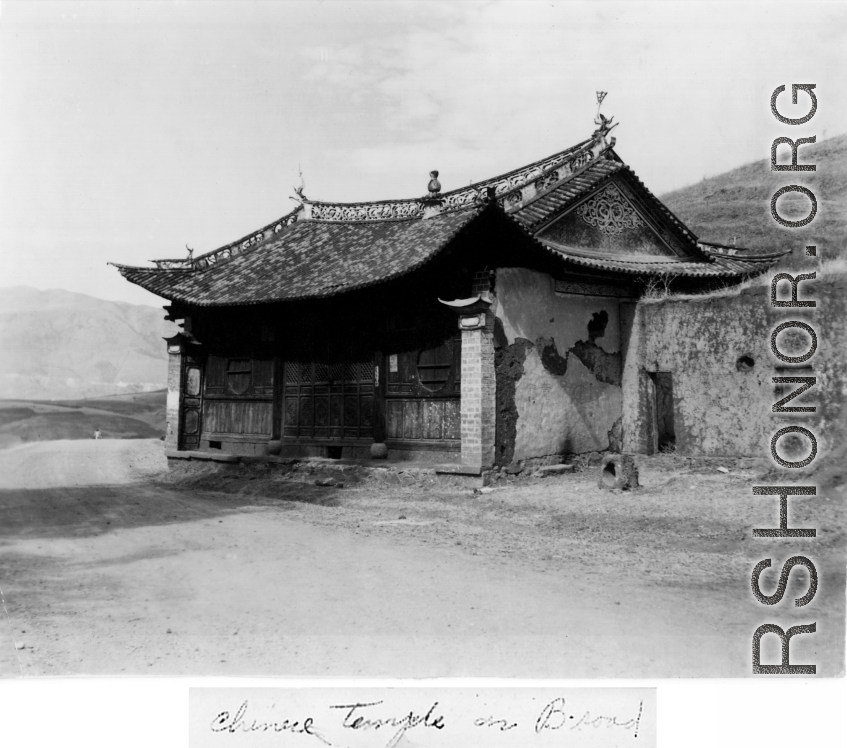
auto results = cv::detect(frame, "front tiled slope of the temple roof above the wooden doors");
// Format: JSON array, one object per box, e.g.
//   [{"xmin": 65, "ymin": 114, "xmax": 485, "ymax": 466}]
[{"xmin": 116, "ymin": 206, "xmax": 484, "ymax": 306}]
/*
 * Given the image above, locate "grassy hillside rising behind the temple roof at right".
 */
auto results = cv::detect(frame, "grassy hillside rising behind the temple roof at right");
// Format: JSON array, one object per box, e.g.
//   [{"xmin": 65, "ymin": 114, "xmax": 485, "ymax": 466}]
[{"xmin": 661, "ymin": 133, "xmax": 847, "ymax": 266}]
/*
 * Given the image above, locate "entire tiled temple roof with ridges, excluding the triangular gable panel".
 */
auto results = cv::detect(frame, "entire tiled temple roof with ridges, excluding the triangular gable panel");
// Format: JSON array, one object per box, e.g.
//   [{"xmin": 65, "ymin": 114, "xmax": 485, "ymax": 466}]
[{"xmin": 116, "ymin": 141, "xmax": 783, "ymax": 306}]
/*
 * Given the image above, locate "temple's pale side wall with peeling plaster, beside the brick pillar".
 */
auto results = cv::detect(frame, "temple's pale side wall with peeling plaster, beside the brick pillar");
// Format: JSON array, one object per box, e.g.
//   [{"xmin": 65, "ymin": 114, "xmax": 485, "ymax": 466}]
[{"xmin": 495, "ymin": 268, "xmax": 622, "ymax": 464}]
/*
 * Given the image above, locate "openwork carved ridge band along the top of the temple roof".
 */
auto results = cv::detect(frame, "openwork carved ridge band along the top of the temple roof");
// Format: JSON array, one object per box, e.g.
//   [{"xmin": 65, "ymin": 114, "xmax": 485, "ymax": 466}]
[{"xmin": 307, "ymin": 140, "xmax": 594, "ymax": 221}]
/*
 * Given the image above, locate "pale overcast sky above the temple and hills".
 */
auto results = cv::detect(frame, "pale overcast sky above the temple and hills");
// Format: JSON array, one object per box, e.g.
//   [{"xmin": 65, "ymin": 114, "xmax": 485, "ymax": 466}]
[{"xmin": 0, "ymin": 0, "xmax": 847, "ymax": 304}]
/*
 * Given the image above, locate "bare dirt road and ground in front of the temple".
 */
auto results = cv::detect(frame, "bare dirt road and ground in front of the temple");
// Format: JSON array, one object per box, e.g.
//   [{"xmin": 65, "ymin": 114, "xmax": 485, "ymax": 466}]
[{"xmin": 0, "ymin": 440, "xmax": 847, "ymax": 678}]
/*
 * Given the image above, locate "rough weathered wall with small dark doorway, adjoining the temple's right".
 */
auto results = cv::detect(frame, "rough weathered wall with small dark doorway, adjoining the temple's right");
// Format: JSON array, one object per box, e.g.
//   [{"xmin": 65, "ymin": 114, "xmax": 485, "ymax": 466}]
[{"xmin": 623, "ymin": 278, "xmax": 847, "ymax": 462}]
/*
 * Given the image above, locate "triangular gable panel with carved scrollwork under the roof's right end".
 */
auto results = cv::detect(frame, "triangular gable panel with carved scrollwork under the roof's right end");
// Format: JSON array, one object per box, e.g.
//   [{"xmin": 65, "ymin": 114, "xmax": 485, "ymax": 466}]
[{"xmin": 539, "ymin": 182, "xmax": 686, "ymax": 257}]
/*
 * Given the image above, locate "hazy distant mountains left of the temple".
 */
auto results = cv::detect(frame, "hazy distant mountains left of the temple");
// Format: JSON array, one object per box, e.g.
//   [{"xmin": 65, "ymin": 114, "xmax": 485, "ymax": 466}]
[{"xmin": 0, "ymin": 286, "xmax": 177, "ymax": 399}]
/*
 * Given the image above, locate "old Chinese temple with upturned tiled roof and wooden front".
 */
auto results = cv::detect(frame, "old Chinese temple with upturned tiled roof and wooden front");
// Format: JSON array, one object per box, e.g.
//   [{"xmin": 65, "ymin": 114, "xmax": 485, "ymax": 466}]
[{"xmin": 117, "ymin": 103, "xmax": 781, "ymax": 474}]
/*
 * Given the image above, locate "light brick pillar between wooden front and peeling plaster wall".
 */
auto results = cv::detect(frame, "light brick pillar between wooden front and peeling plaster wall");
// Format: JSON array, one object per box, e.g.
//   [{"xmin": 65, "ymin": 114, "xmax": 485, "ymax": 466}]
[{"xmin": 459, "ymin": 312, "xmax": 495, "ymax": 468}]
